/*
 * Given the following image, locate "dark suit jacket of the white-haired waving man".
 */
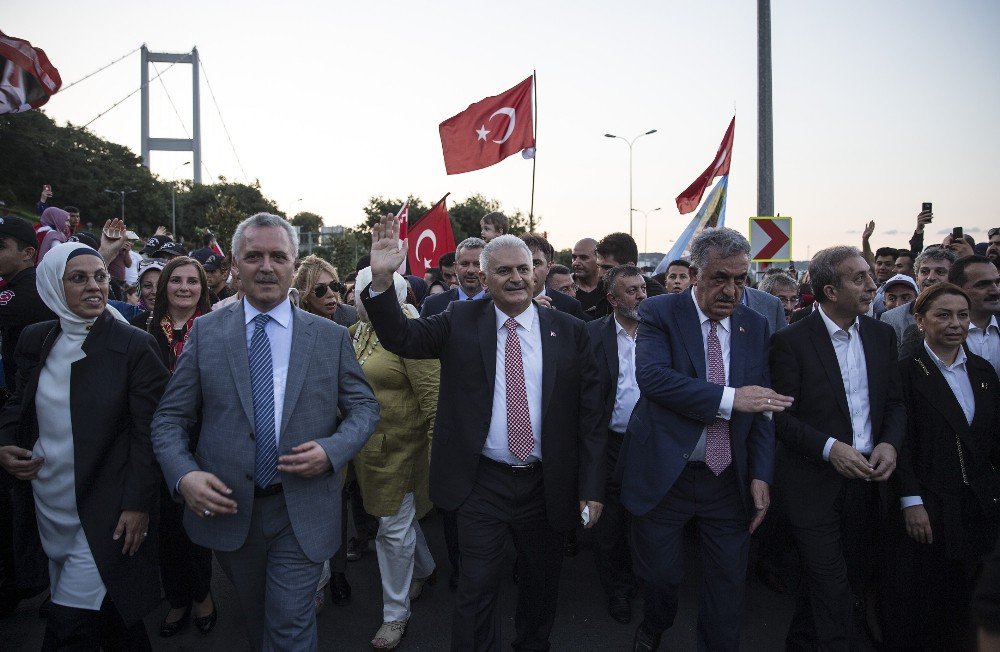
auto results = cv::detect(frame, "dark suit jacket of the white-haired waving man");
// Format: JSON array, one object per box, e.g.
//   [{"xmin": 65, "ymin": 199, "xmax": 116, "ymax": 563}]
[{"xmin": 362, "ymin": 288, "xmax": 605, "ymax": 530}]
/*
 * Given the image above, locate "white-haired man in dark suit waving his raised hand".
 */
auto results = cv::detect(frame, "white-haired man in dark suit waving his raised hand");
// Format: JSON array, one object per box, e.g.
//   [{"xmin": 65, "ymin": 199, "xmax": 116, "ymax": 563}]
[{"xmin": 361, "ymin": 220, "xmax": 604, "ymax": 652}]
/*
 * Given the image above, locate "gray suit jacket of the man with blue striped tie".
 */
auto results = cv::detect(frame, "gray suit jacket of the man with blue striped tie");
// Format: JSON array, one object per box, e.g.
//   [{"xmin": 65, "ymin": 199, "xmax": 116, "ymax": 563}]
[{"xmin": 152, "ymin": 301, "xmax": 379, "ymax": 563}]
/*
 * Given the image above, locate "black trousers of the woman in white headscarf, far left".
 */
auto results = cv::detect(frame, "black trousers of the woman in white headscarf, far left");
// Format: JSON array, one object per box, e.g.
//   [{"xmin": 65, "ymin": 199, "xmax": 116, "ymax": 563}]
[{"xmin": 42, "ymin": 597, "xmax": 153, "ymax": 652}]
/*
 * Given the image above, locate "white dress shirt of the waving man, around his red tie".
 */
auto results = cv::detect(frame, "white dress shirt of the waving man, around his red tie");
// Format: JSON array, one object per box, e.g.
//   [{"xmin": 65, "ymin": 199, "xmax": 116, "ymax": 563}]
[{"xmin": 482, "ymin": 304, "xmax": 542, "ymax": 464}]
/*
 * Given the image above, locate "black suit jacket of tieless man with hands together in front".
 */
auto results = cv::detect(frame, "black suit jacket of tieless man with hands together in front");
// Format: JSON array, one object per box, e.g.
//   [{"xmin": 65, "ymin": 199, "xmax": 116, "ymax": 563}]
[{"xmin": 770, "ymin": 311, "xmax": 906, "ymax": 523}]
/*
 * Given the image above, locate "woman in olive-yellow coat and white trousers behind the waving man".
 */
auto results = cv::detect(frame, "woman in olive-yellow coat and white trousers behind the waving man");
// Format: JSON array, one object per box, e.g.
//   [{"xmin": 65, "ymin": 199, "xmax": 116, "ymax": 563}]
[{"xmin": 350, "ymin": 267, "xmax": 441, "ymax": 650}]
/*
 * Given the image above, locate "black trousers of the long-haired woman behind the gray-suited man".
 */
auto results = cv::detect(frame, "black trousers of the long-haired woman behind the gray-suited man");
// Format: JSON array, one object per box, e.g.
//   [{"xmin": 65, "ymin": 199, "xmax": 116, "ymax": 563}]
[{"xmin": 160, "ymin": 496, "xmax": 212, "ymax": 609}]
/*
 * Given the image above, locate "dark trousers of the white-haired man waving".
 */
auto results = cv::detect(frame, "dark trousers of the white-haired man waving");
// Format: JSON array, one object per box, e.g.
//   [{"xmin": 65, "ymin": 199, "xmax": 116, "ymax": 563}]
[{"xmin": 451, "ymin": 460, "xmax": 563, "ymax": 652}]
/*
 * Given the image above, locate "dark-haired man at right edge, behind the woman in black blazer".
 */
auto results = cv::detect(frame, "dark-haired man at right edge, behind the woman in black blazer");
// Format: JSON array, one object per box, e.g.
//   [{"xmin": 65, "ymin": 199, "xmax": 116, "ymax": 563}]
[{"xmin": 948, "ymin": 256, "xmax": 1000, "ymax": 374}]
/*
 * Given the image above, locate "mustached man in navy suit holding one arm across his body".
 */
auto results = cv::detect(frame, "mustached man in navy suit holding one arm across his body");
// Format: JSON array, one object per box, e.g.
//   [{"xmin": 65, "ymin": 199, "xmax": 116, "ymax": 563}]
[{"xmin": 620, "ymin": 228, "xmax": 792, "ymax": 650}]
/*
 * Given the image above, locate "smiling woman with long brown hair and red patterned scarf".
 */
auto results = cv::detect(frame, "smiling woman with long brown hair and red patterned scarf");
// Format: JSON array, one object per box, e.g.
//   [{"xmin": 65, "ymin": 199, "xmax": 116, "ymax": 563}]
[{"xmin": 132, "ymin": 256, "xmax": 218, "ymax": 638}]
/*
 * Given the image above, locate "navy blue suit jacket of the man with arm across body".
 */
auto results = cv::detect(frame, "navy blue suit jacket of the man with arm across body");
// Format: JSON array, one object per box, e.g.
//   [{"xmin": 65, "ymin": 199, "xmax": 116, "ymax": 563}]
[{"xmin": 622, "ymin": 290, "xmax": 774, "ymax": 516}]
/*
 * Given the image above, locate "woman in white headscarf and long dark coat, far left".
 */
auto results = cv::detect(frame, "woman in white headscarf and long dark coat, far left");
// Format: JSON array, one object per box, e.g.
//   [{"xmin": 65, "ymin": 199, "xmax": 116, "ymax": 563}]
[{"xmin": 0, "ymin": 243, "xmax": 167, "ymax": 650}]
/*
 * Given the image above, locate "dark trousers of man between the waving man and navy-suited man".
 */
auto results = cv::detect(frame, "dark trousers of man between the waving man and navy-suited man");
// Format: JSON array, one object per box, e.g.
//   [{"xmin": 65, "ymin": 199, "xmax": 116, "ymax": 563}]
[{"xmin": 593, "ymin": 430, "xmax": 635, "ymax": 598}]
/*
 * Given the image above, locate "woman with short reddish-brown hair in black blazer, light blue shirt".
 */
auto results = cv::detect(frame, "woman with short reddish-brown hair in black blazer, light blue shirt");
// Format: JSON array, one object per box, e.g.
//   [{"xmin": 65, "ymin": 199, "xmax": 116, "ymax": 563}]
[{"xmin": 880, "ymin": 283, "xmax": 1000, "ymax": 650}]
